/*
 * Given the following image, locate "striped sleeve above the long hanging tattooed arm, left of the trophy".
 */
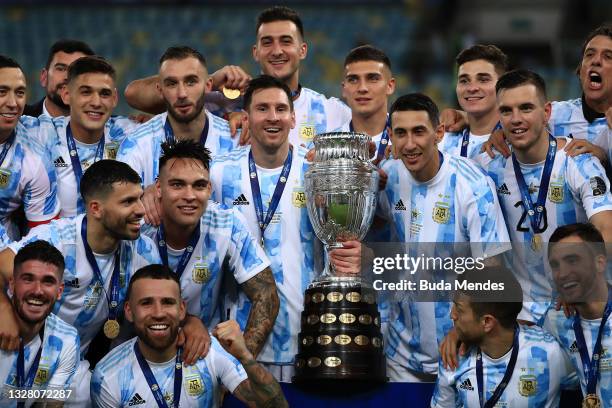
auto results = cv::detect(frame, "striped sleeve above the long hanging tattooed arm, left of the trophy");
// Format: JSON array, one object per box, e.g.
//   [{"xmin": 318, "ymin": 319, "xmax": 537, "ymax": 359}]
[{"xmin": 228, "ymin": 209, "xmax": 270, "ymax": 284}]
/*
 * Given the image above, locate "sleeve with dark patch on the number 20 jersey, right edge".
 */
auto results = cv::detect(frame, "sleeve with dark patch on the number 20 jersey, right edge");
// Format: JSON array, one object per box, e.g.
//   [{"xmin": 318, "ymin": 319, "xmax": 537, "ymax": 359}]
[{"xmin": 566, "ymin": 154, "xmax": 612, "ymax": 219}]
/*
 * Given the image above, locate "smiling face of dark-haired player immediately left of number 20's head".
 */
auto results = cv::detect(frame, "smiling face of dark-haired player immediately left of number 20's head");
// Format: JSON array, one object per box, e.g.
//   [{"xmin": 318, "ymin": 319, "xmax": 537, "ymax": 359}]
[{"xmin": 456, "ymin": 59, "xmax": 498, "ymax": 117}]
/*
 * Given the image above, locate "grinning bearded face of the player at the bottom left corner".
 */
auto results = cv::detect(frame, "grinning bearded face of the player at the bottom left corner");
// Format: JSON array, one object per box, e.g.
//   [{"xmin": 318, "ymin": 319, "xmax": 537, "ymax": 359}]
[{"xmin": 10, "ymin": 260, "xmax": 64, "ymax": 325}]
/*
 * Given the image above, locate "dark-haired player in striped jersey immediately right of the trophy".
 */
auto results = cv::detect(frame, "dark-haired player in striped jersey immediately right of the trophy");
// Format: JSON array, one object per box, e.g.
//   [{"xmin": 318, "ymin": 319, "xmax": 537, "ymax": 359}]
[{"xmin": 378, "ymin": 94, "xmax": 509, "ymax": 382}]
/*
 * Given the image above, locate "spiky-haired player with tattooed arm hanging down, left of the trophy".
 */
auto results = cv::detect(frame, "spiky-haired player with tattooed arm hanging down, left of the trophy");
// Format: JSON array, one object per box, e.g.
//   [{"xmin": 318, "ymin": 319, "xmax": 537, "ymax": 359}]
[{"xmin": 143, "ymin": 140, "xmax": 278, "ymax": 356}]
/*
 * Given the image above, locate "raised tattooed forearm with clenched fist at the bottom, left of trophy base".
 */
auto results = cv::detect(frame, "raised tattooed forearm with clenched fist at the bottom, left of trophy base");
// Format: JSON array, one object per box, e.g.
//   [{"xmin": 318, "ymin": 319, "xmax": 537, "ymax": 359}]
[{"xmin": 213, "ymin": 320, "xmax": 289, "ymax": 408}]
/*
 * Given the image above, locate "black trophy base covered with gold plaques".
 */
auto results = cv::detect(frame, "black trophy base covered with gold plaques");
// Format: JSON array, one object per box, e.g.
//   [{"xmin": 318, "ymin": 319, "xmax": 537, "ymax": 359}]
[{"xmin": 293, "ymin": 277, "xmax": 387, "ymax": 383}]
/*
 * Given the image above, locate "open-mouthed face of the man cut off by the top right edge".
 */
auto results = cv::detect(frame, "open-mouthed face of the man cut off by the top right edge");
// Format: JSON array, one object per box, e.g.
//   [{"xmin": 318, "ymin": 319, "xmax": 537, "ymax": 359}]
[{"xmin": 580, "ymin": 35, "xmax": 612, "ymax": 113}]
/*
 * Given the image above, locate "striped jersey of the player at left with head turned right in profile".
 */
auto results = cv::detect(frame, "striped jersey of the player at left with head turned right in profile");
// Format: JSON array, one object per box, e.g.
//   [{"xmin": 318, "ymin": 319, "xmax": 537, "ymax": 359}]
[{"xmin": 9, "ymin": 215, "xmax": 161, "ymax": 355}]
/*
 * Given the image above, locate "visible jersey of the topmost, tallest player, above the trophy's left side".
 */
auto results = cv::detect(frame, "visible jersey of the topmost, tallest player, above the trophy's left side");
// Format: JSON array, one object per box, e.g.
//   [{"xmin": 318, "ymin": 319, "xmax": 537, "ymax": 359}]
[{"xmin": 289, "ymin": 87, "xmax": 351, "ymax": 147}]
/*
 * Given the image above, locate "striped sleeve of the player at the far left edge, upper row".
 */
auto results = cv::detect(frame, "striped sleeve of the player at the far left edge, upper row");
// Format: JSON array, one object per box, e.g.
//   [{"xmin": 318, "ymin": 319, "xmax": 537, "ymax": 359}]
[{"xmin": 23, "ymin": 153, "xmax": 60, "ymax": 222}]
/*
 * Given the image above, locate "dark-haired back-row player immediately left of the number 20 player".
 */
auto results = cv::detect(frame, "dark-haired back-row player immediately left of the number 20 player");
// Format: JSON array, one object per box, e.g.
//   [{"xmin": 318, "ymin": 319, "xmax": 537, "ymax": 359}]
[{"xmin": 439, "ymin": 44, "xmax": 508, "ymax": 158}]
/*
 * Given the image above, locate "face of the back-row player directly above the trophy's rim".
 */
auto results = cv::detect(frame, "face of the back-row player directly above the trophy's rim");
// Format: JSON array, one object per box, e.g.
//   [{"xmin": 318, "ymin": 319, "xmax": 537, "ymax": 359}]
[{"xmin": 342, "ymin": 61, "xmax": 395, "ymax": 116}]
